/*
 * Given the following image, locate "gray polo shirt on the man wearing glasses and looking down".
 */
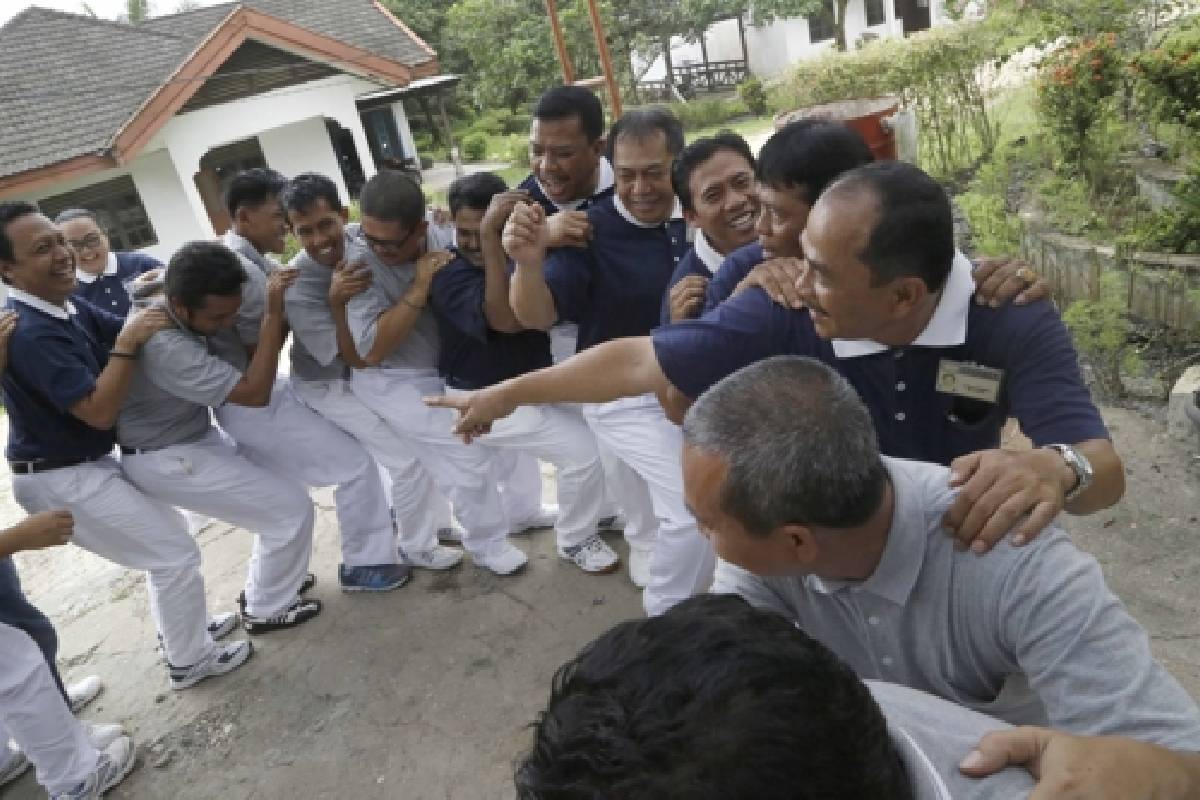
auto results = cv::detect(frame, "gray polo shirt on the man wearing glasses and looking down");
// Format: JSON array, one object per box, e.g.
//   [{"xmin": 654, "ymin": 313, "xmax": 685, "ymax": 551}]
[{"xmin": 347, "ymin": 229, "xmax": 449, "ymax": 372}]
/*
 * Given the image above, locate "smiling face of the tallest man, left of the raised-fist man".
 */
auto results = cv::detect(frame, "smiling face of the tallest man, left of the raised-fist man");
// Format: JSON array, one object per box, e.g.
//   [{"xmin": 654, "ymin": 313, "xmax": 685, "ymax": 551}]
[{"xmin": 529, "ymin": 116, "xmax": 604, "ymax": 205}]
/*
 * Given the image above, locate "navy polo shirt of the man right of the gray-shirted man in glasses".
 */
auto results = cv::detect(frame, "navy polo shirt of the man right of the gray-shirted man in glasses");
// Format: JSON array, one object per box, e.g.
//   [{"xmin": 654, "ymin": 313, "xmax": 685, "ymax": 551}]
[{"xmin": 430, "ymin": 248, "xmax": 551, "ymax": 390}]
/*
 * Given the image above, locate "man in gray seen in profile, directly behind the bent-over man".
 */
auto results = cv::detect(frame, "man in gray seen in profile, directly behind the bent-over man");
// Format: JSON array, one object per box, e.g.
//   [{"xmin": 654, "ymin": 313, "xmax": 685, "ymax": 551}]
[{"xmin": 214, "ymin": 169, "xmax": 410, "ymax": 591}]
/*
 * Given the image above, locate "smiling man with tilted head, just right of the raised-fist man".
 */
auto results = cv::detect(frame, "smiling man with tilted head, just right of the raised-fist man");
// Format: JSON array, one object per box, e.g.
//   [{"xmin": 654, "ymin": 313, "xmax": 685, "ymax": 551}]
[{"xmin": 662, "ymin": 131, "xmax": 758, "ymax": 325}]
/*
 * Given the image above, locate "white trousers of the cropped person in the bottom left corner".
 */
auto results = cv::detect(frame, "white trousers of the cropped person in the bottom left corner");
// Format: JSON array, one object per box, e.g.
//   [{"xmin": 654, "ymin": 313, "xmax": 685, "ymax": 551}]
[{"xmin": 0, "ymin": 624, "xmax": 100, "ymax": 795}]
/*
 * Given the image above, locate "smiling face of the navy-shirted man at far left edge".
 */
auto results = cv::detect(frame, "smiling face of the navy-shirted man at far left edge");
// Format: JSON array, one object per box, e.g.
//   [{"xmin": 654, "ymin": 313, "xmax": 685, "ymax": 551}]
[{"xmin": 0, "ymin": 213, "xmax": 77, "ymax": 306}]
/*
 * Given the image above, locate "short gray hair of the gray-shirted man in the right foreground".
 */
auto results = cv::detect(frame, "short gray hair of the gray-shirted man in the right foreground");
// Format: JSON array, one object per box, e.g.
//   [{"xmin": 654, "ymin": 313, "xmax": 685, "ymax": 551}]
[{"xmin": 683, "ymin": 356, "xmax": 887, "ymax": 536}]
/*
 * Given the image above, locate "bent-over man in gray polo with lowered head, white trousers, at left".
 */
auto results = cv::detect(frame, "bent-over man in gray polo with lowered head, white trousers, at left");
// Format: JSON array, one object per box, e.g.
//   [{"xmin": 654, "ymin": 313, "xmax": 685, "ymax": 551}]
[{"xmin": 116, "ymin": 242, "xmax": 320, "ymax": 633}]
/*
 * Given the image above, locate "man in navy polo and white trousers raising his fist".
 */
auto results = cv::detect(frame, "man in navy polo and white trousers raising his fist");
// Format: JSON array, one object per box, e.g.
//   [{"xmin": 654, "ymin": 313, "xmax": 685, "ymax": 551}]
[{"xmin": 504, "ymin": 108, "xmax": 712, "ymax": 614}]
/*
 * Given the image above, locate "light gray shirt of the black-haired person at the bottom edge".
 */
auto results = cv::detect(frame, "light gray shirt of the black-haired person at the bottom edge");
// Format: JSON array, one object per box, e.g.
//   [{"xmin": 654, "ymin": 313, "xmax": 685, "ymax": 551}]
[{"xmin": 866, "ymin": 680, "xmax": 1033, "ymax": 800}]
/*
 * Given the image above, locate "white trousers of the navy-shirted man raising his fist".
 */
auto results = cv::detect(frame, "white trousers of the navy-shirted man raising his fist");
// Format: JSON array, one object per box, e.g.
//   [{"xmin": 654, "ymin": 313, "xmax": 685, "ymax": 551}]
[{"xmin": 583, "ymin": 395, "xmax": 716, "ymax": 616}]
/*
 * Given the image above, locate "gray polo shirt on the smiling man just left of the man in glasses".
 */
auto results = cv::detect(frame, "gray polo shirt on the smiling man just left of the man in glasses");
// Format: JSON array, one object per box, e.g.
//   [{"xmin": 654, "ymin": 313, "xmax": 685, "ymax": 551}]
[{"xmin": 283, "ymin": 225, "xmax": 365, "ymax": 380}]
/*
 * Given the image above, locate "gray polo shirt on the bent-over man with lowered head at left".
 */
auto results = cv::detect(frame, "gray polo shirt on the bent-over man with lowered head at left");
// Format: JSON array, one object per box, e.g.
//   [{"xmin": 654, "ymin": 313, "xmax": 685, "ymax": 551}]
[{"xmin": 116, "ymin": 303, "xmax": 241, "ymax": 450}]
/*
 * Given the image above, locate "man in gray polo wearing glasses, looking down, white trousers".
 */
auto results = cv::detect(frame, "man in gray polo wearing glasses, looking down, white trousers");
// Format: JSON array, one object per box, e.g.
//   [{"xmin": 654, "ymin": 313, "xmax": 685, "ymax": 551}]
[{"xmin": 347, "ymin": 170, "xmax": 528, "ymax": 575}]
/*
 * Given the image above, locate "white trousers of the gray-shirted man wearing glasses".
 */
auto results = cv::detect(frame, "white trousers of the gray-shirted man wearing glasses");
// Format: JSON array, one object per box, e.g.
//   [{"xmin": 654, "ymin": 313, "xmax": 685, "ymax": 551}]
[{"xmin": 350, "ymin": 369, "xmax": 508, "ymax": 555}]
